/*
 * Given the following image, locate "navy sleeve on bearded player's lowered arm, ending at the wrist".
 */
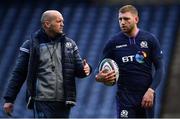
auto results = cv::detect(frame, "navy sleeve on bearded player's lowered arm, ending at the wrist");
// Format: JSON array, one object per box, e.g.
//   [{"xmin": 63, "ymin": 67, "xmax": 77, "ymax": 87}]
[{"xmin": 150, "ymin": 37, "xmax": 164, "ymax": 90}]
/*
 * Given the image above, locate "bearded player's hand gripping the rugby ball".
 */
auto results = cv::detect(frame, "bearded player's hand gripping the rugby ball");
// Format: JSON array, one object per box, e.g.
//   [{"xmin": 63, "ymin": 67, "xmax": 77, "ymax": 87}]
[{"xmin": 96, "ymin": 69, "xmax": 116, "ymax": 83}]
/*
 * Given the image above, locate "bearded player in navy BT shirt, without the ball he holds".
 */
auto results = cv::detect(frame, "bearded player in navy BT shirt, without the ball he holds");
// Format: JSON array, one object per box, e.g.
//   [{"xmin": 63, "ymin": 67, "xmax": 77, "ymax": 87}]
[{"xmin": 96, "ymin": 5, "xmax": 164, "ymax": 118}]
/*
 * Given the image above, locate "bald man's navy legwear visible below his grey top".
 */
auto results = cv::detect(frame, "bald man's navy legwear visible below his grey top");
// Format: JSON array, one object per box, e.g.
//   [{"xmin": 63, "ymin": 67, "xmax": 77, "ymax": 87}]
[{"xmin": 34, "ymin": 101, "xmax": 71, "ymax": 118}]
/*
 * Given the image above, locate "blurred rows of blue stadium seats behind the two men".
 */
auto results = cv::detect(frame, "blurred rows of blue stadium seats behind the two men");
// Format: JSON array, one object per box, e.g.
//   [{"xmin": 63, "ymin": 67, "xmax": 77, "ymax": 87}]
[{"xmin": 0, "ymin": 0, "xmax": 180, "ymax": 118}]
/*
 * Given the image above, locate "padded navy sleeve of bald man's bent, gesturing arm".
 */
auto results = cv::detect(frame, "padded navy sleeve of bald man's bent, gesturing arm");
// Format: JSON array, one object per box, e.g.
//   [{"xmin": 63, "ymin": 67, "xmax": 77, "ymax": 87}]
[{"xmin": 74, "ymin": 42, "xmax": 92, "ymax": 78}]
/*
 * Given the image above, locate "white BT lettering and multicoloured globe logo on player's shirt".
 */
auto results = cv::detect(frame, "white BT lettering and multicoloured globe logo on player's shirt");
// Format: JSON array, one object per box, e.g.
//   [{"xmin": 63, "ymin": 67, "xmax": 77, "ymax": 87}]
[{"xmin": 122, "ymin": 51, "xmax": 147, "ymax": 63}]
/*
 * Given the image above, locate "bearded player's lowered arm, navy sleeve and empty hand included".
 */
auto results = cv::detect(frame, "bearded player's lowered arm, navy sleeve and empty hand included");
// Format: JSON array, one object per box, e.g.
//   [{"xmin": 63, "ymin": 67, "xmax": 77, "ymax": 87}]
[{"xmin": 142, "ymin": 34, "xmax": 164, "ymax": 108}]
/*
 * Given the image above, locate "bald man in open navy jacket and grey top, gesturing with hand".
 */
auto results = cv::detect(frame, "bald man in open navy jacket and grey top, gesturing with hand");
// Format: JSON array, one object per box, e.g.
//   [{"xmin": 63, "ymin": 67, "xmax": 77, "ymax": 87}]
[{"xmin": 4, "ymin": 10, "xmax": 91, "ymax": 118}]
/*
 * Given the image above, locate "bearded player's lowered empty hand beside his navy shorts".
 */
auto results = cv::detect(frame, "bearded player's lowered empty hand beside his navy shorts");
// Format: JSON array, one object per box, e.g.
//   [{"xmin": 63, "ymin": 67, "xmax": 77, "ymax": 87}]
[{"xmin": 141, "ymin": 88, "xmax": 154, "ymax": 109}]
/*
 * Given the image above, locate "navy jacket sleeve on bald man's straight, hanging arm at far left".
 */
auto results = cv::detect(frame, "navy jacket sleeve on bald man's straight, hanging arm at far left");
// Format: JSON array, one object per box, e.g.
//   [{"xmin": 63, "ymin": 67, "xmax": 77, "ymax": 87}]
[{"xmin": 4, "ymin": 41, "xmax": 29, "ymax": 103}]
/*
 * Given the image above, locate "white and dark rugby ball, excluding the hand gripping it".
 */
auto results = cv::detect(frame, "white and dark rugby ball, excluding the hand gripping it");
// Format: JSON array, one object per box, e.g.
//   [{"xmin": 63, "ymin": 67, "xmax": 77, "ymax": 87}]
[{"xmin": 99, "ymin": 58, "xmax": 119, "ymax": 86}]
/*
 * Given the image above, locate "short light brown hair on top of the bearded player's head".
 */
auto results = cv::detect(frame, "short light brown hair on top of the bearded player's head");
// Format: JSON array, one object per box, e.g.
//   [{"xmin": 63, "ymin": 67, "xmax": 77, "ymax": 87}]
[{"xmin": 119, "ymin": 5, "xmax": 138, "ymax": 16}]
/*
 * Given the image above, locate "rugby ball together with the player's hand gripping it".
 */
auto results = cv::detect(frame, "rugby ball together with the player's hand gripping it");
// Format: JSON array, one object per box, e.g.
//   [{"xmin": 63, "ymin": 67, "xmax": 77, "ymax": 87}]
[{"xmin": 96, "ymin": 58, "xmax": 119, "ymax": 86}]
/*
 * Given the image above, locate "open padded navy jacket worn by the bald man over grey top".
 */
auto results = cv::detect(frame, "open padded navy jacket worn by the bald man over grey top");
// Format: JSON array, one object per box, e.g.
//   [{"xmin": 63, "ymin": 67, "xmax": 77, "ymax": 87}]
[{"xmin": 4, "ymin": 29, "xmax": 91, "ymax": 108}]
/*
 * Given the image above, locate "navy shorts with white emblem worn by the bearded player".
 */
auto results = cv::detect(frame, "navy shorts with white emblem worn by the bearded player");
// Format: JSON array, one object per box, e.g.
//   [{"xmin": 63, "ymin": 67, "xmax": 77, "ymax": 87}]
[{"xmin": 116, "ymin": 90, "xmax": 154, "ymax": 118}]
